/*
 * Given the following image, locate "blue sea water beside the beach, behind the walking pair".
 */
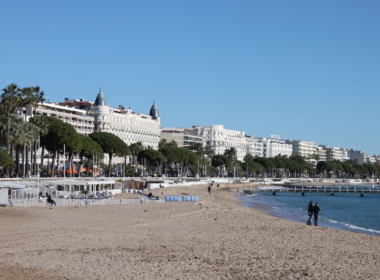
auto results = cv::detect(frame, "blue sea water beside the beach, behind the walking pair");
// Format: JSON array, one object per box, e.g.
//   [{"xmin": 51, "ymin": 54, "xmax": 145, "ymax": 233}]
[{"xmin": 240, "ymin": 187, "xmax": 380, "ymax": 235}]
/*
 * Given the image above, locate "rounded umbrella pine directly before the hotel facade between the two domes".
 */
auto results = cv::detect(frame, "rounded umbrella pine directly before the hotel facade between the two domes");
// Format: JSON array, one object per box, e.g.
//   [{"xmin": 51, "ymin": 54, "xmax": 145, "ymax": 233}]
[{"xmin": 89, "ymin": 132, "xmax": 131, "ymax": 176}]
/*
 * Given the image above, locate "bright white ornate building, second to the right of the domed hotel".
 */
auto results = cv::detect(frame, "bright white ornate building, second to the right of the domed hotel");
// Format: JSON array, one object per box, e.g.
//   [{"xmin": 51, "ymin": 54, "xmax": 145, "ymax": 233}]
[{"xmin": 197, "ymin": 125, "xmax": 246, "ymax": 161}]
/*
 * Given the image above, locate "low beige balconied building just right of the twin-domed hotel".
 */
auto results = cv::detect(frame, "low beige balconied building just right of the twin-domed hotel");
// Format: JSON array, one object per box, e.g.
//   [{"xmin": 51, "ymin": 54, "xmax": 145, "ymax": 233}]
[{"xmin": 160, "ymin": 127, "xmax": 203, "ymax": 147}]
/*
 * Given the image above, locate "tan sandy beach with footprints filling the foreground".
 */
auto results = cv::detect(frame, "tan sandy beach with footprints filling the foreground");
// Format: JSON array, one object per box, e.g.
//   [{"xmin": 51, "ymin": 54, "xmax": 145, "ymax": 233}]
[{"xmin": 0, "ymin": 184, "xmax": 380, "ymax": 279}]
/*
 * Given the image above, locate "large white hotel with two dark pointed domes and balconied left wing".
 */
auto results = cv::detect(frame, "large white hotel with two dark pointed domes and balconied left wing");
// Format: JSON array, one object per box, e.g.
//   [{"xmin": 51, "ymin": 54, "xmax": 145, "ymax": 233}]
[{"xmin": 17, "ymin": 90, "xmax": 160, "ymax": 166}]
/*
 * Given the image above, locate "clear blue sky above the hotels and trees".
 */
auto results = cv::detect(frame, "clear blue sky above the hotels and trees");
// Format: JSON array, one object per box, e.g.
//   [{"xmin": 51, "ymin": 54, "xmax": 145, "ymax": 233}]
[{"xmin": 0, "ymin": 0, "xmax": 380, "ymax": 154}]
